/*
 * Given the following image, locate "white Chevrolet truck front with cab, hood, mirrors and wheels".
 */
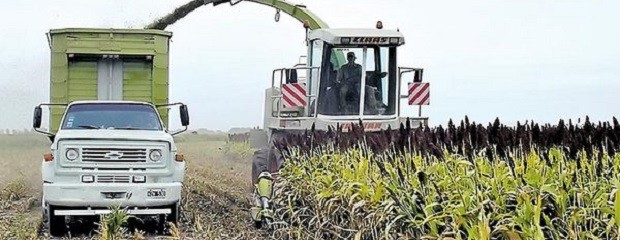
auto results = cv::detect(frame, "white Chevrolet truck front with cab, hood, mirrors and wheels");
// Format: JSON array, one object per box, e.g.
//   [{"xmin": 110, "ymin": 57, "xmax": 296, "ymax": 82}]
[{"xmin": 33, "ymin": 101, "xmax": 189, "ymax": 236}]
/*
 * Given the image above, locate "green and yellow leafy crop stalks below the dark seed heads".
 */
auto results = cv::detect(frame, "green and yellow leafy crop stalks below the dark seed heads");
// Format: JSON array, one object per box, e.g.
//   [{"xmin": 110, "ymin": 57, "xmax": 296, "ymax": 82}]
[{"xmin": 274, "ymin": 129, "xmax": 620, "ymax": 239}]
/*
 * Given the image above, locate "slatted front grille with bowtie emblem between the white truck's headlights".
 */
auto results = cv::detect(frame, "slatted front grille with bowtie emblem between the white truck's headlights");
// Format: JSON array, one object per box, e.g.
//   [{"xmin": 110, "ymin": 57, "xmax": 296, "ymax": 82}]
[{"xmin": 82, "ymin": 147, "xmax": 147, "ymax": 163}]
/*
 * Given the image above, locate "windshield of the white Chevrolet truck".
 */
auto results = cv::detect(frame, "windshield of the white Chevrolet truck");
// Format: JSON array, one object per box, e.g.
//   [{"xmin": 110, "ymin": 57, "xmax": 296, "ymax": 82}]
[{"xmin": 62, "ymin": 103, "xmax": 162, "ymax": 130}]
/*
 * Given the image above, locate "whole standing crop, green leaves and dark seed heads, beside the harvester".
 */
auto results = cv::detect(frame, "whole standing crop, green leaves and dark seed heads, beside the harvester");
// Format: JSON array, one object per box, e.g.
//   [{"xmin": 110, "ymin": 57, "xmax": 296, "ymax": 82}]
[{"xmin": 260, "ymin": 118, "xmax": 620, "ymax": 239}]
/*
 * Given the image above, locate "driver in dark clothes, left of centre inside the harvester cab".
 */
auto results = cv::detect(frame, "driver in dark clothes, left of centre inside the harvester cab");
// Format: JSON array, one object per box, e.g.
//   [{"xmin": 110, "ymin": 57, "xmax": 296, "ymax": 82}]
[{"xmin": 336, "ymin": 52, "xmax": 362, "ymax": 112}]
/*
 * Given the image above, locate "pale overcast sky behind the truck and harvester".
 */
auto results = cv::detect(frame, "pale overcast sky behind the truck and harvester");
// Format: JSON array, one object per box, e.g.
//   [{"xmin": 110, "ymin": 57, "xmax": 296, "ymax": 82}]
[{"xmin": 0, "ymin": 0, "xmax": 620, "ymax": 130}]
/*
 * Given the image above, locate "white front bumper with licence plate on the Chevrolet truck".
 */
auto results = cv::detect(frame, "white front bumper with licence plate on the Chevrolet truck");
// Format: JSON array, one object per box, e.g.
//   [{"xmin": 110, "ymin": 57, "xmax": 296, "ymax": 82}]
[{"xmin": 43, "ymin": 182, "xmax": 182, "ymax": 210}]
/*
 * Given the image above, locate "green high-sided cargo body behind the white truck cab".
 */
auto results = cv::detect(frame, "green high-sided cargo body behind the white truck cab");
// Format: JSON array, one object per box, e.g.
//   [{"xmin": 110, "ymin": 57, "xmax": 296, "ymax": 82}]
[{"xmin": 48, "ymin": 28, "xmax": 172, "ymax": 133}]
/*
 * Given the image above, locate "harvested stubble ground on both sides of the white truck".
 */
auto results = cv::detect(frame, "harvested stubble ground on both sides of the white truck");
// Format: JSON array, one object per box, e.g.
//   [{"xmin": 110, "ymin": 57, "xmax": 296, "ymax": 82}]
[{"xmin": 0, "ymin": 133, "xmax": 270, "ymax": 239}]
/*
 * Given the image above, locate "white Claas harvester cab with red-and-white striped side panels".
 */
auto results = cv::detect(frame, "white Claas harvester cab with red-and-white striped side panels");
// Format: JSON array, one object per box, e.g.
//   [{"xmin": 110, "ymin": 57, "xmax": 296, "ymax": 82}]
[{"xmin": 264, "ymin": 28, "xmax": 429, "ymax": 135}]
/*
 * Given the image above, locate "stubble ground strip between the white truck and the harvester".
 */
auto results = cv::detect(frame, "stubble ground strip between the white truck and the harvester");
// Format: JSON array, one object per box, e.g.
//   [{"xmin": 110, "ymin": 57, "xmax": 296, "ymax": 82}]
[{"xmin": 174, "ymin": 136, "xmax": 268, "ymax": 239}]
